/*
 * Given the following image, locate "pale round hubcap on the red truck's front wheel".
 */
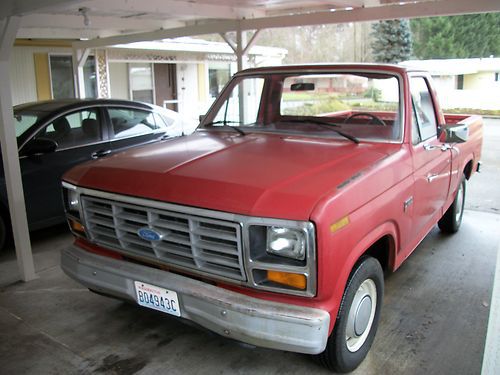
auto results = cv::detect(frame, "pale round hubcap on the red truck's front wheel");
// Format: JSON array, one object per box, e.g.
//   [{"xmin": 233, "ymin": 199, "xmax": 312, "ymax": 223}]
[{"xmin": 345, "ymin": 279, "xmax": 377, "ymax": 352}]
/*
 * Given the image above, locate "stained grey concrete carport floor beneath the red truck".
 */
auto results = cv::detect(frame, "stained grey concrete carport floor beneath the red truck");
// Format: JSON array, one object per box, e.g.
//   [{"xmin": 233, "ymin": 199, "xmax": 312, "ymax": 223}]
[{"xmin": 0, "ymin": 120, "xmax": 500, "ymax": 375}]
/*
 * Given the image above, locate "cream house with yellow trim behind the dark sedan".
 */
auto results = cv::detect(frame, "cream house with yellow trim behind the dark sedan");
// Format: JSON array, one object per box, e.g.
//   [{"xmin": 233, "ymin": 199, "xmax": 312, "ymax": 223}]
[{"xmin": 11, "ymin": 38, "xmax": 286, "ymax": 118}]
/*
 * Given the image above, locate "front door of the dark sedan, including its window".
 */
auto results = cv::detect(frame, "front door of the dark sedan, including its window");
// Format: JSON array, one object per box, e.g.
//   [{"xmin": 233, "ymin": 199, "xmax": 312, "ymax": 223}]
[{"xmin": 20, "ymin": 107, "xmax": 110, "ymax": 229}]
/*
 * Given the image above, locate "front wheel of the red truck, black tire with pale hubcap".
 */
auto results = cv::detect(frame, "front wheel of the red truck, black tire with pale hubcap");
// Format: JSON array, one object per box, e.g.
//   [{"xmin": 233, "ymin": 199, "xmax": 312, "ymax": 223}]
[{"xmin": 318, "ymin": 257, "xmax": 384, "ymax": 372}]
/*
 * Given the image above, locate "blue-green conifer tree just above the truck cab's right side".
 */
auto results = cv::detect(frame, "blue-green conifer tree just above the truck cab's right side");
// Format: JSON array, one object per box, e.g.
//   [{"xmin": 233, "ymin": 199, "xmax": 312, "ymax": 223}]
[{"xmin": 371, "ymin": 19, "xmax": 412, "ymax": 63}]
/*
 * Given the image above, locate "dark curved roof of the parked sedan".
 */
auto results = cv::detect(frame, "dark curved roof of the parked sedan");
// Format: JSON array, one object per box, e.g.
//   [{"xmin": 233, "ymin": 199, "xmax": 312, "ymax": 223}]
[{"xmin": 14, "ymin": 99, "xmax": 161, "ymax": 112}]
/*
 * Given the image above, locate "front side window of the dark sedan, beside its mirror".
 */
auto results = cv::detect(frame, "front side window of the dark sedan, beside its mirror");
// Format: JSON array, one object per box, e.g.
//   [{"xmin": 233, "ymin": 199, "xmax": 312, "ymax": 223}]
[{"xmin": 35, "ymin": 108, "xmax": 102, "ymax": 150}]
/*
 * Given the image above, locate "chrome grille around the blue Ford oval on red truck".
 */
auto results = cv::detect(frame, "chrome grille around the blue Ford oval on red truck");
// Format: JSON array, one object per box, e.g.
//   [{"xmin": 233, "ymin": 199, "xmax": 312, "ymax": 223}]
[{"xmin": 81, "ymin": 196, "xmax": 246, "ymax": 280}]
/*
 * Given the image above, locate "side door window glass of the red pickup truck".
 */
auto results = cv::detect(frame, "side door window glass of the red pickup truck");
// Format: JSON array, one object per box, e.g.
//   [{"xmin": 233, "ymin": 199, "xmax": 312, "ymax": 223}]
[{"xmin": 410, "ymin": 77, "xmax": 437, "ymax": 143}]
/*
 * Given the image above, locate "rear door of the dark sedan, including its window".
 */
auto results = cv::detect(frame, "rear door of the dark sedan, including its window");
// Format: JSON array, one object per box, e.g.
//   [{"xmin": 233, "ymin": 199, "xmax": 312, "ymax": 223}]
[{"xmin": 107, "ymin": 106, "xmax": 168, "ymax": 152}]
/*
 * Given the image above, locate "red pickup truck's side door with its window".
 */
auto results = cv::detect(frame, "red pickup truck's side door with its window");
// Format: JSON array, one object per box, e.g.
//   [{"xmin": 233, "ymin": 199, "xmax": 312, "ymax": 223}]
[{"xmin": 410, "ymin": 76, "xmax": 452, "ymax": 238}]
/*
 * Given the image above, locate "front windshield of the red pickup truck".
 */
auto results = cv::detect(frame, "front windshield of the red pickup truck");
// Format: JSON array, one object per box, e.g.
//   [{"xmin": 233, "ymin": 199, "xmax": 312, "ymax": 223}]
[{"xmin": 202, "ymin": 71, "xmax": 402, "ymax": 142}]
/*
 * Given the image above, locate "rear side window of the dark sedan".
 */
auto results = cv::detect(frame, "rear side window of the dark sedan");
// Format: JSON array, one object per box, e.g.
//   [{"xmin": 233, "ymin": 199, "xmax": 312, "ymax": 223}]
[{"xmin": 108, "ymin": 108, "xmax": 161, "ymax": 139}]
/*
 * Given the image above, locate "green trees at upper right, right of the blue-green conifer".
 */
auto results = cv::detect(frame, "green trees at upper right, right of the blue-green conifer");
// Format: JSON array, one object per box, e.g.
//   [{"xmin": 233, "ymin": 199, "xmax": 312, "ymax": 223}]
[{"xmin": 411, "ymin": 13, "xmax": 500, "ymax": 59}]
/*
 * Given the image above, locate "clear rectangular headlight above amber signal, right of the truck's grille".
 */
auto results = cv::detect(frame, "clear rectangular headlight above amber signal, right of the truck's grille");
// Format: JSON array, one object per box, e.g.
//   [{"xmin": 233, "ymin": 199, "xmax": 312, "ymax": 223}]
[{"xmin": 266, "ymin": 227, "xmax": 306, "ymax": 260}]
